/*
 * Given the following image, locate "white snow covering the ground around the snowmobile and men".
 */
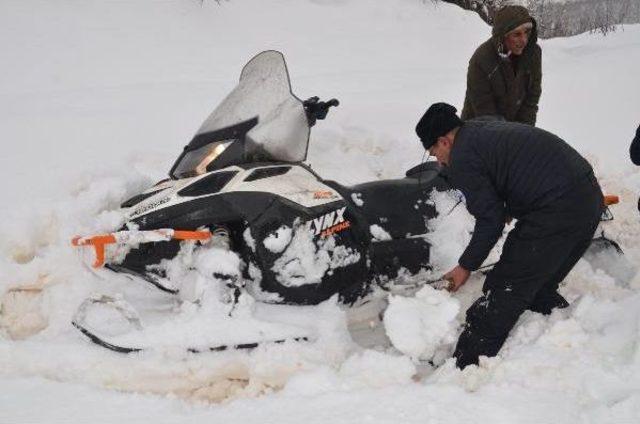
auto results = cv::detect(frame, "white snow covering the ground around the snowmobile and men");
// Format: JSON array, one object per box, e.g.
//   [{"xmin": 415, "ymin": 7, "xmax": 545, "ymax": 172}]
[{"xmin": 0, "ymin": 0, "xmax": 640, "ymax": 423}]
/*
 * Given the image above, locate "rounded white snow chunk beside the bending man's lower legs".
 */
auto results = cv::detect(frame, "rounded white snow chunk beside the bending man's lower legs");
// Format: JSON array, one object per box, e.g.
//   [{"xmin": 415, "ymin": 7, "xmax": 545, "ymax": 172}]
[{"xmin": 384, "ymin": 286, "xmax": 460, "ymax": 360}]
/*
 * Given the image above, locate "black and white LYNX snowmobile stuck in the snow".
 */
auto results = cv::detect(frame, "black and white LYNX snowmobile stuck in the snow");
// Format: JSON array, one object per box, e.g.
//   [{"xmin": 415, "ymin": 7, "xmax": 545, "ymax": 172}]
[{"xmin": 72, "ymin": 51, "xmax": 624, "ymax": 352}]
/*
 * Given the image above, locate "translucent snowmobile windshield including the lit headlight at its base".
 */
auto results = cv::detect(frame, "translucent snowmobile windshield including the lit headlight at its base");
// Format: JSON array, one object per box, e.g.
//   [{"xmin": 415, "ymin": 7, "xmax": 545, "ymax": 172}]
[{"xmin": 170, "ymin": 51, "xmax": 310, "ymax": 178}]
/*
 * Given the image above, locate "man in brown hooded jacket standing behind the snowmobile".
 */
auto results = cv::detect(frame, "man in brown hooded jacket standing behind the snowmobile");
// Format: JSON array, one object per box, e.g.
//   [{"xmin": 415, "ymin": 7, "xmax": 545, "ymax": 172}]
[{"xmin": 462, "ymin": 6, "xmax": 542, "ymax": 125}]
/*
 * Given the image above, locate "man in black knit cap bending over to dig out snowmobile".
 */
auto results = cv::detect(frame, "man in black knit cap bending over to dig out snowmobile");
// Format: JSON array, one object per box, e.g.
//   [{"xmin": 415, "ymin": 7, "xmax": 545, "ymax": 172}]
[{"xmin": 416, "ymin": 103, "xmax": 603, "ymax": 368}]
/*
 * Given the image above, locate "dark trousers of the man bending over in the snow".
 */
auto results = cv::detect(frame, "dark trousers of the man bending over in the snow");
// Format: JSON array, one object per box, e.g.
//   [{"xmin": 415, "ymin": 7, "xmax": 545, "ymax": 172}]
[{"xmin": 454, "ymin": 175, "xmax": 603, "ymax": 368}]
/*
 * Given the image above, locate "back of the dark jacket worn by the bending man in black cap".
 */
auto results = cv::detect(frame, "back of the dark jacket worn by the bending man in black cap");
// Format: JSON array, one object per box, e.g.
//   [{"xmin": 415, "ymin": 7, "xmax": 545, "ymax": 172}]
[{"xmin": 449, "ymin": 121, "xmax": 593, "ymax": 218}]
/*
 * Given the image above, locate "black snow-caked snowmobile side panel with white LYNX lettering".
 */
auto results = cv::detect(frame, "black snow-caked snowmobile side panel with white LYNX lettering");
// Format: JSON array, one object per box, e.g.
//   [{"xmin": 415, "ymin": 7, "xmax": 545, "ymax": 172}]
[{"xmin": 251, "ymin": 198, "xmax": 368, "ymax": 305}]
